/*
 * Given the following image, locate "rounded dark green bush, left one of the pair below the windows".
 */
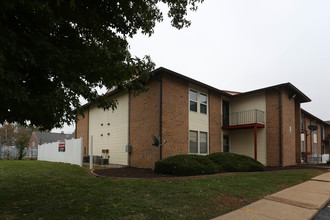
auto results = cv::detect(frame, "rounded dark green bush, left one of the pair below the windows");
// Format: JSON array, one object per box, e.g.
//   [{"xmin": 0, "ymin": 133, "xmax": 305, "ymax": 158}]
[{"xmin": 155, "ymin": 155, "xmax": 222, "ymax": 176}]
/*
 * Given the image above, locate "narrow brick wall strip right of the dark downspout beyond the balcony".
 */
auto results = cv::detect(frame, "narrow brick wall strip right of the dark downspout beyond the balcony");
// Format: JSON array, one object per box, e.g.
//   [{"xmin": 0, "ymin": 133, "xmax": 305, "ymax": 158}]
[{"xmin": 282, "ymin": 89, "xmax": 296, "ymax": 166}]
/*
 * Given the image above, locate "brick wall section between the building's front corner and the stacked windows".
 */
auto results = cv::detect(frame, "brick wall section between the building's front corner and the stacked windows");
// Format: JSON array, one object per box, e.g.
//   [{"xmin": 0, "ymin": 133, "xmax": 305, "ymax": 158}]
[{"xmin": 162, "ymin": 75, "xmax": 189, "ymax": 158}]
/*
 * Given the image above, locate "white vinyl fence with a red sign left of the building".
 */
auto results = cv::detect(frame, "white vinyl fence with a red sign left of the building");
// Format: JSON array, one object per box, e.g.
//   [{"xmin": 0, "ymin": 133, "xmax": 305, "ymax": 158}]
[{"xmin": 38, "ymin": 138, "xmax": 83, "ymax": 166}]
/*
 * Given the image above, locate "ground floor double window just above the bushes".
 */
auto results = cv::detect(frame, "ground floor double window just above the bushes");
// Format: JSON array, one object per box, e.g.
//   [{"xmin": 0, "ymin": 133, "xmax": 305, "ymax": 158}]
[{"xmin": 189, "ymin": 131, "xmax": 208, "ymax": 154}]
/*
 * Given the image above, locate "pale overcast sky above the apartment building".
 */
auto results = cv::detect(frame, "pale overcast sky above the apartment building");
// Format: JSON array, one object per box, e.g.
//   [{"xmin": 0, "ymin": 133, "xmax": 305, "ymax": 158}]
[{"xmin": 52, "ymin": 0, "xmax": 330, "ymax": 131}]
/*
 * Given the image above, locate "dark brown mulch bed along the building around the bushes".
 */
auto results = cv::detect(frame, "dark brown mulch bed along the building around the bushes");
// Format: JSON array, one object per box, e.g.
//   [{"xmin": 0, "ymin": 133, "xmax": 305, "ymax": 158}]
[{"xmin": 94, "ymin": 164, "xmax": 330, "ymax": 179}]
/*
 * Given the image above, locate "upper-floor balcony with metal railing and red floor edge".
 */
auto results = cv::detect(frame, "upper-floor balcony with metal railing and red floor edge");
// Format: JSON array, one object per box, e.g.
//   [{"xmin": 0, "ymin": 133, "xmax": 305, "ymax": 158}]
[{"xmin": 222, "ymin": 109, "xmax": 265, "ymax": 130}]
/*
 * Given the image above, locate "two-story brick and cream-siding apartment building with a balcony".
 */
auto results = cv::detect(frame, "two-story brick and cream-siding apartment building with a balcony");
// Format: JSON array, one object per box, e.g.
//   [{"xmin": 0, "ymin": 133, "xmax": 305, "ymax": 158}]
[{"xmin": 76, "ymin": 67, "xmax": 330, "ymax": 168}]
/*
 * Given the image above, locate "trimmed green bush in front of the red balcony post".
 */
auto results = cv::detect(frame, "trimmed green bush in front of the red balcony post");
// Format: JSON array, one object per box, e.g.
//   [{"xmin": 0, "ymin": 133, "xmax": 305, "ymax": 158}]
[{"xmin": 207, "ymin": 152, "xmax": 265, "ymax": 172}]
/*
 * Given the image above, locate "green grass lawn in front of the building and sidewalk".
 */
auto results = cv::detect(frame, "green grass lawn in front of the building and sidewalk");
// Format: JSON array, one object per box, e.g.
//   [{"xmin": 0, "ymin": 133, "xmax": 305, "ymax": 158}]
[{"xmin": 0, "ymin": 160, "xmax": 321, "ymax": 219}]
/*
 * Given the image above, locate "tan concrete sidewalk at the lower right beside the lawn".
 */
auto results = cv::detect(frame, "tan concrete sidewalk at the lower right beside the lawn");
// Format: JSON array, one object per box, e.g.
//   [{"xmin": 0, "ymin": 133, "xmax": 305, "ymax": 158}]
[{"xmin": 214, "ymin": 172, "xmax": 330, "ymax": 220}]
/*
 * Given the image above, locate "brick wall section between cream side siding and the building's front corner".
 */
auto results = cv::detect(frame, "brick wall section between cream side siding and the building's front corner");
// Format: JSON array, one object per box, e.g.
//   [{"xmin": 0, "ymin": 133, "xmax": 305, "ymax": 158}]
[{"xmin": 129, "ymin": 80, "xmax": 159, "ymax": 168}]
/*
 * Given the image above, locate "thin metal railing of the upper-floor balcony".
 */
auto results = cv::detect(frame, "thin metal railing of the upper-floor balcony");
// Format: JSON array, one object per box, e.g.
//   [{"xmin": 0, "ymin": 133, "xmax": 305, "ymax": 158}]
[{"xmin": 223, "ymin": 109, "xmax": 265, "ymax": 126}]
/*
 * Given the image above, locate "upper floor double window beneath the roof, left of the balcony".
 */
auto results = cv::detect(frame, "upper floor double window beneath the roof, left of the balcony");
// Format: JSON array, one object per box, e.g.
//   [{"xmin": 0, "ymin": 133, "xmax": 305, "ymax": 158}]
[{"xmin": 189, "ymin": 90, "xmax": 207, "ymax": 114}]
